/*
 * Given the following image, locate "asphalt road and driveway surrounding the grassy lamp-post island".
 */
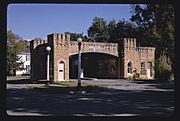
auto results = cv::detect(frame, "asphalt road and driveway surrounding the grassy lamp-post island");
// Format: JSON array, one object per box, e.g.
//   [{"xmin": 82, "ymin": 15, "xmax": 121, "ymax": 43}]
[{"xmin": 7, "ymin": 79, "xmax": 174, "ymax": 116}]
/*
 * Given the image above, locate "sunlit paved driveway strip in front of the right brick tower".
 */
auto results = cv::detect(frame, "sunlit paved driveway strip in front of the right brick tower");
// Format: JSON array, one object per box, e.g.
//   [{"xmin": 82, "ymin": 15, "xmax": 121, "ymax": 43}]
[{"xmin": 81, "ymin": 79, "xmax": 174, "ymax": 91}]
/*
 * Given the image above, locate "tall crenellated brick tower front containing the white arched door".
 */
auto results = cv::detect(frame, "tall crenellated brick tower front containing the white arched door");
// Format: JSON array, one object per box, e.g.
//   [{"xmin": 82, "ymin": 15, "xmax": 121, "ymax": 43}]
[{"xmin": 47, "ymin": 33, "xmax": 70, "ymax": 81}]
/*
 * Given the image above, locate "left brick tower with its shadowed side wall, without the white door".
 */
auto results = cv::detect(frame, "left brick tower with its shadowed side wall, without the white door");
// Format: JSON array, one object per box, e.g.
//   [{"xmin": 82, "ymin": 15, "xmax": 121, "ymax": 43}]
[{"xmin": 30, "ymin": 33, "xmax": 70, "ymax": 82}]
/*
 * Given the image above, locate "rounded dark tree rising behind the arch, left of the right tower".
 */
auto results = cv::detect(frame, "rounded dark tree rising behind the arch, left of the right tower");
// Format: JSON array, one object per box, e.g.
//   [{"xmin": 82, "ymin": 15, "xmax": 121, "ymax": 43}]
[{"xmin": 88, "ymin": 17, "xmax": 138, "ymax": 43}]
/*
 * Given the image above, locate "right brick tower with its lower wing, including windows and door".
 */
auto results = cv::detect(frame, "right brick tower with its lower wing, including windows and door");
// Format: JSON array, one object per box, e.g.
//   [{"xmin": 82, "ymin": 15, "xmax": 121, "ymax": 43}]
[{"xmin": 122, "ymin": 38, "xmax": 155, "ymax": 79}]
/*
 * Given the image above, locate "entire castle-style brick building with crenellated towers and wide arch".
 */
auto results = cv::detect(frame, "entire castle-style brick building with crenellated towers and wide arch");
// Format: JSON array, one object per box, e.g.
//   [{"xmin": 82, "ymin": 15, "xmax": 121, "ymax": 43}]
[{"xmin": 30, "ymin": 33, "xmax": 155, "ymax": 82}]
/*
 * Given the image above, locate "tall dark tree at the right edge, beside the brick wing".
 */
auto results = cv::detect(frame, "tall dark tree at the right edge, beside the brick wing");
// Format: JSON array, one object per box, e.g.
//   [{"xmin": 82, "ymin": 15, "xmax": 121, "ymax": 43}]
[{"xmin": 131, "ymin": 4, "xmax": 175, "ymax": 81}]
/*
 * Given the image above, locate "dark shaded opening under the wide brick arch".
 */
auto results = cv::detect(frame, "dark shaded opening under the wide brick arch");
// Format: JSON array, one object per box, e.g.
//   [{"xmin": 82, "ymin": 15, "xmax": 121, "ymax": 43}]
[{"xmin": 69, "ymin": 53, "xmax": 118, "ymax": 79}]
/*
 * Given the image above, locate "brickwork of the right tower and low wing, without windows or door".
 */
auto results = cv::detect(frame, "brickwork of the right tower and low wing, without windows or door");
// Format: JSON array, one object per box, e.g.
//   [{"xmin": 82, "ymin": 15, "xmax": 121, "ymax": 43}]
[{"xmin": 124, "ymin": 38, "xmax": 155, "ymax": 79}]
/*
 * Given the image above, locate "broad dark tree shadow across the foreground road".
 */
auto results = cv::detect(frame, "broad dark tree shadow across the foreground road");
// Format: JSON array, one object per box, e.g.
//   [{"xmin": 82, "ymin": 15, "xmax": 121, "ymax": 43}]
[{"xmin": 7, "ymin": 82, "xmax": 174, "ymax": 116}]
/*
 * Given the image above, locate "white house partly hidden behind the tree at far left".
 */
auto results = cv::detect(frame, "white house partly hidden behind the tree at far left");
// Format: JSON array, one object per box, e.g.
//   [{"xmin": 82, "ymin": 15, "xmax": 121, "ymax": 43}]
[{"xmin": 16, "ymin": 45, "xmax": 31, "ymax": 75}]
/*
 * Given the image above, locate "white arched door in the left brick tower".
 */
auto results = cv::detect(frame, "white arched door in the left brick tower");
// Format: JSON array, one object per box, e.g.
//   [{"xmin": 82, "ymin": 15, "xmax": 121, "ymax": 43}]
[{"xmin": 58, "ymin": 61, "xmax": 65, "ymax": 81}]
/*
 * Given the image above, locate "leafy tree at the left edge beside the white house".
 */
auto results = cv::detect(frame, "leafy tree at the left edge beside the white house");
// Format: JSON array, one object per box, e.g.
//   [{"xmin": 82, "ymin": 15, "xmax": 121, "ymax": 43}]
[{"xmin": 7, "ymin": 31, "xmax": 27, "ymax": 76}]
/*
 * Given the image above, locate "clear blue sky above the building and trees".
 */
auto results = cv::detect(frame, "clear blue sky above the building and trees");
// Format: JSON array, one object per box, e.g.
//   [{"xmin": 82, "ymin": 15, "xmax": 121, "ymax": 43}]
[{"xmin": 7, "ymin": 4, "xmax": 134, "ymax": 40}]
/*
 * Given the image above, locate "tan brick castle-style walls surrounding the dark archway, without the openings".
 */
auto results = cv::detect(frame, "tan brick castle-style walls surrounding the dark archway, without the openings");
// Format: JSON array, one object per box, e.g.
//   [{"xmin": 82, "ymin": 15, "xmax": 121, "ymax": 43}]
[{"xmin": 30, "ymin": 34, "xmax": 155, "ymax": 81}]
